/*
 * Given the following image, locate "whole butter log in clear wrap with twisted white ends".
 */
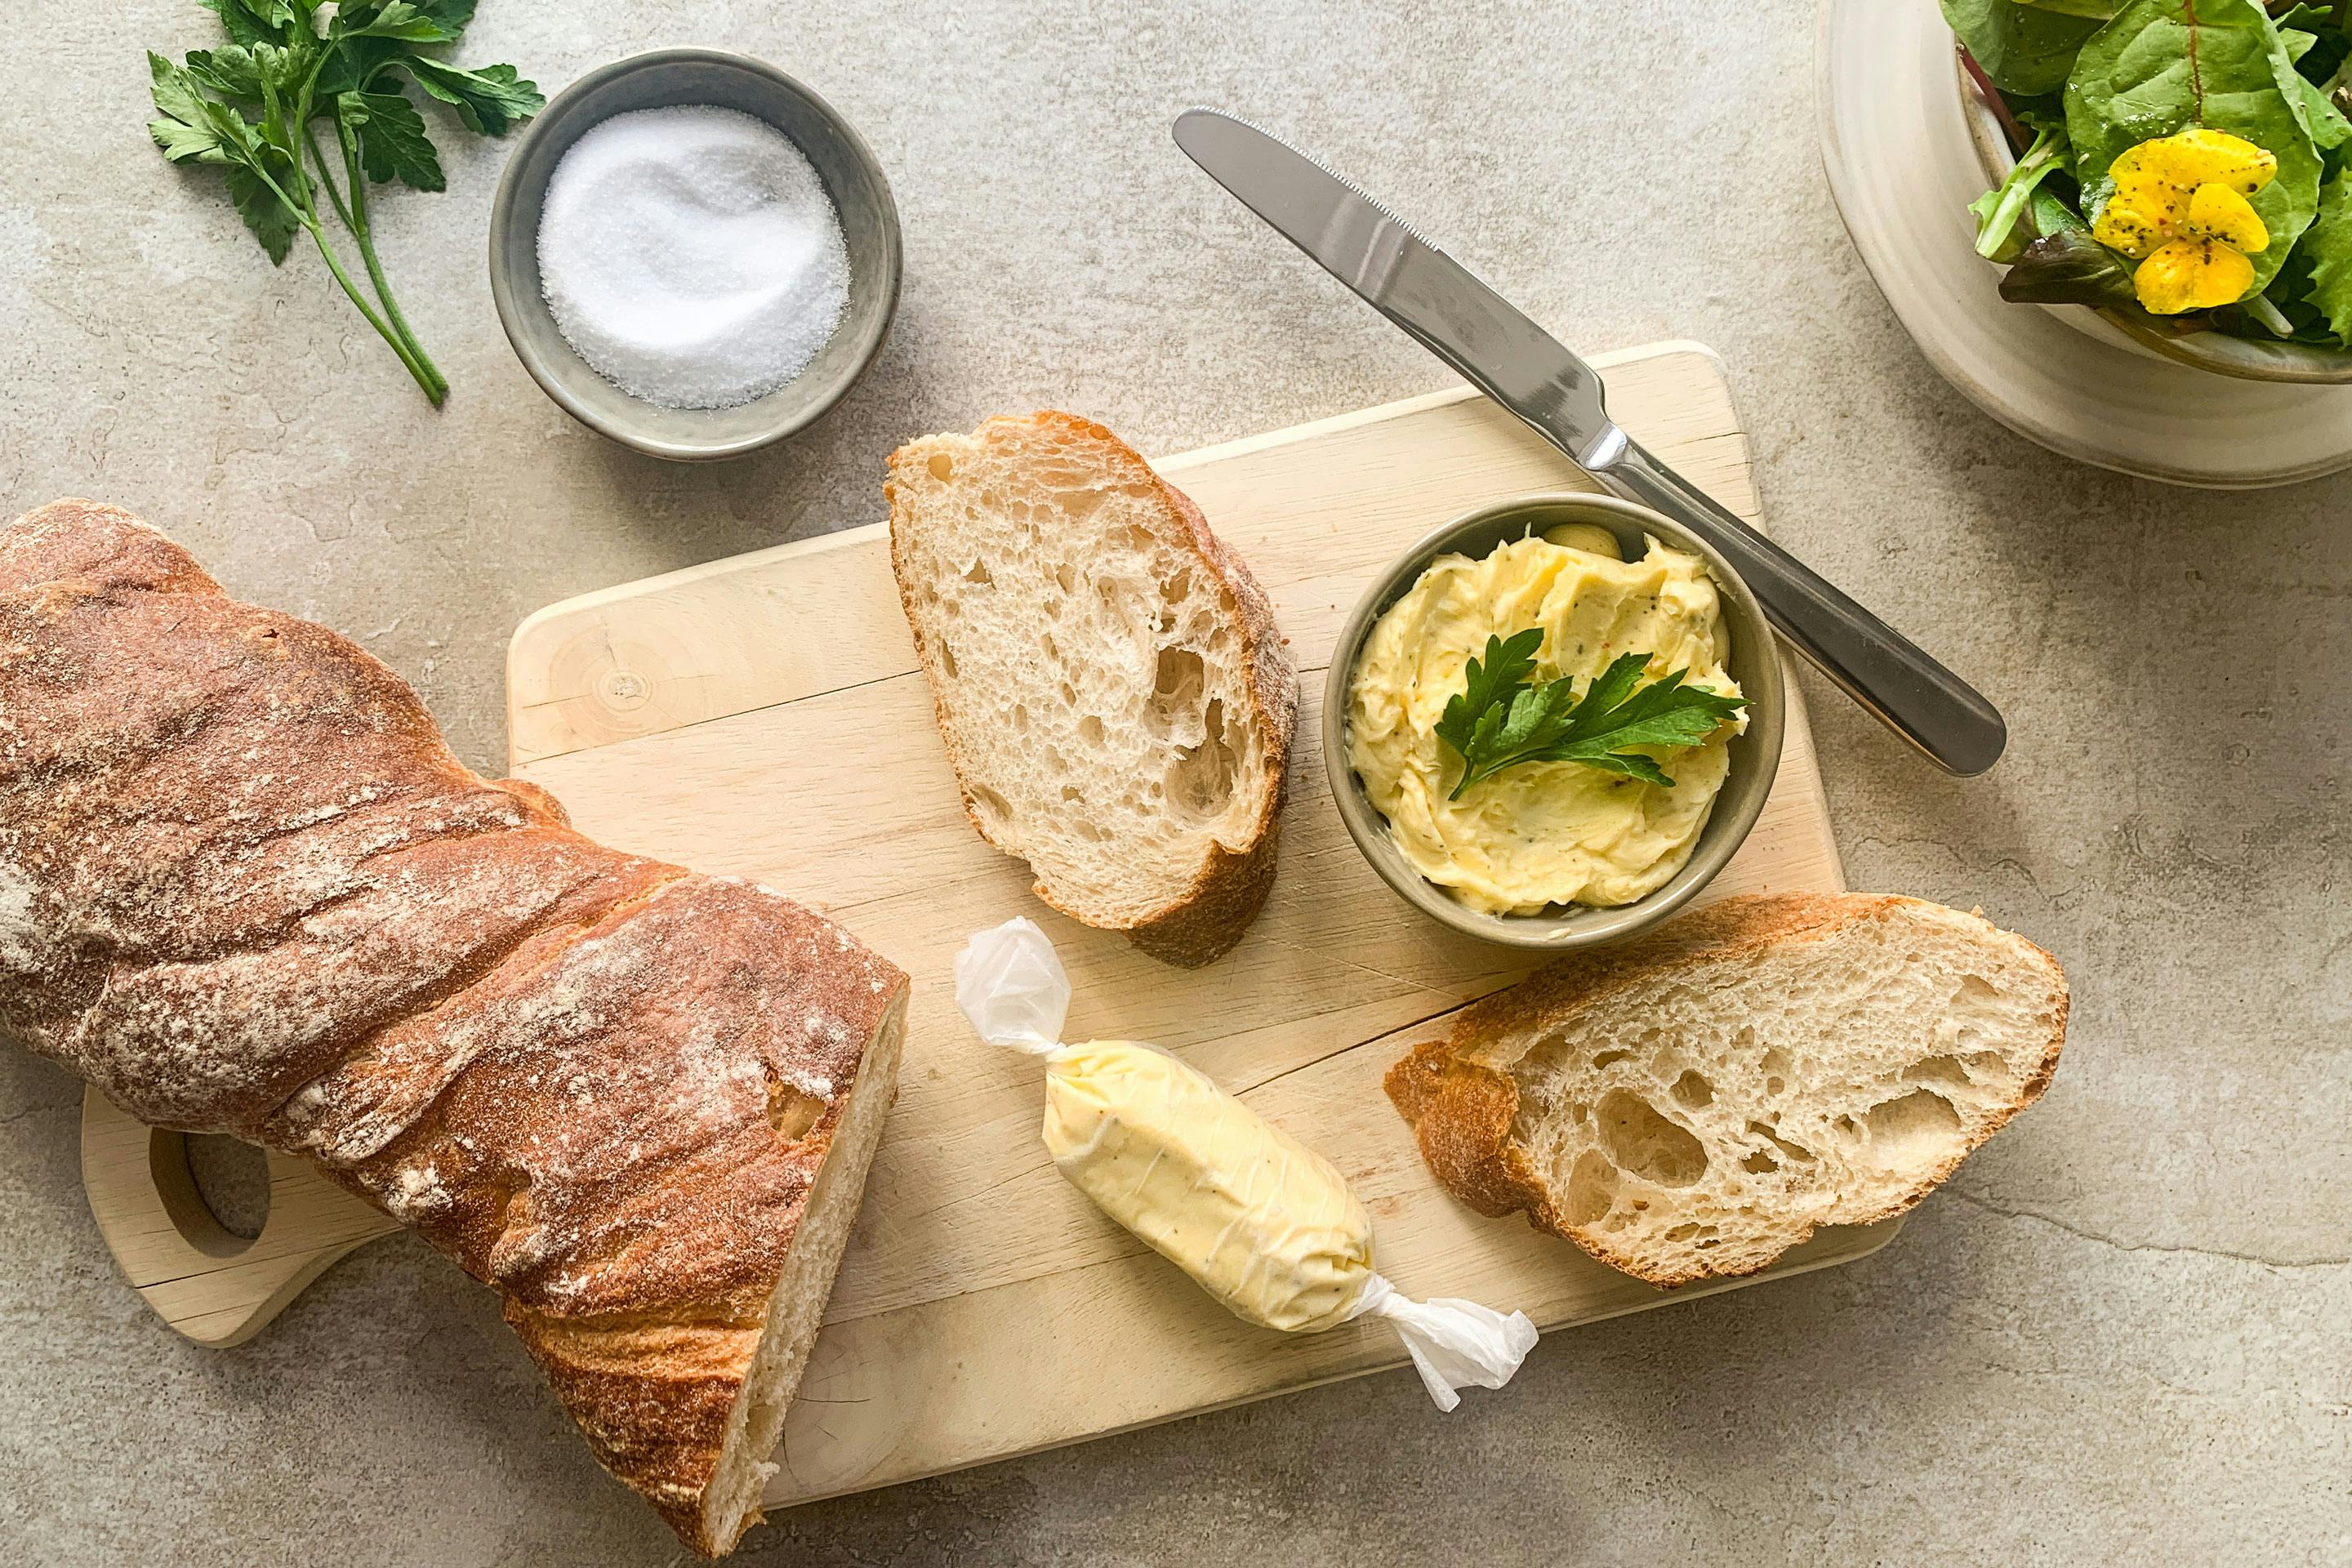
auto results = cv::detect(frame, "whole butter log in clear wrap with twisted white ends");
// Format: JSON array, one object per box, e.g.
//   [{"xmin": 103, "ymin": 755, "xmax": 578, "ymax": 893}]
[{"xmin": 955, "ymin": 920, "xmax": 1536, "ymax": 1410}]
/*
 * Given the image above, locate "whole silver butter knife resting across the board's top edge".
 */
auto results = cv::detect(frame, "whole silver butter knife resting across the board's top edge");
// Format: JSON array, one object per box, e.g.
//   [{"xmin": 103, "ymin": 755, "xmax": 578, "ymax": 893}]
[{"xmin": 1176, "ymin": 108, "xmax": 2009, "ymax": 776}]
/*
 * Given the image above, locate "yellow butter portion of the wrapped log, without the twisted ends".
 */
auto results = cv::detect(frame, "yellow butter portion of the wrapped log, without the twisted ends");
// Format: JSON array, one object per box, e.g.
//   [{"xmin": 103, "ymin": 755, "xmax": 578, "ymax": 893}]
[{"xmin": 1045, "ymin": 1039, "xmax": 1371, "ymax": 1333}]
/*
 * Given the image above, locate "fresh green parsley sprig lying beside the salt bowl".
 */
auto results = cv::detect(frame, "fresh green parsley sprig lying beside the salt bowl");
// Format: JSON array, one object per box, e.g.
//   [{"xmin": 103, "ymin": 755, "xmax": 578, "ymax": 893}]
[{"xmin": 148, "ymin": 0, "xmax": 546, "ymax": 407}]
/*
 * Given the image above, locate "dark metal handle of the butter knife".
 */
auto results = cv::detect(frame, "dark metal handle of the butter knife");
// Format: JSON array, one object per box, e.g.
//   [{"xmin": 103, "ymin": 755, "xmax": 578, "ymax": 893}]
[{"xmin": 1590, "ymin": 442, "xmax": 2009, "ymax": 778}]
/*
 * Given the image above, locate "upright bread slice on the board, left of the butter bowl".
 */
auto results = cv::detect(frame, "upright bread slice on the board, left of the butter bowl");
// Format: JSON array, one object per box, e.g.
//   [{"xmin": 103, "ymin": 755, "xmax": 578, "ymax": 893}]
[{"xmin": 884, "ymin": 412, "xmax": 1298, "ymax": 966}]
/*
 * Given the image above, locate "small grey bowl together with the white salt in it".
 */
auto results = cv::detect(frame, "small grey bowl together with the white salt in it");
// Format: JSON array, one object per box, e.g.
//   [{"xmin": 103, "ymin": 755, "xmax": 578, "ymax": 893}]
[{"xmin": 489, "ymin": 49, "xmax": 901, "ymax": 461}]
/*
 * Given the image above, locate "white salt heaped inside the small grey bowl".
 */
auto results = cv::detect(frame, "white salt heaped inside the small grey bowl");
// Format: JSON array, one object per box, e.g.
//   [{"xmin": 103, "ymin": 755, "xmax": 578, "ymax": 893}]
[{"xmin": 539, "ymin": 104, "xmax": 849, "ymax": 409}]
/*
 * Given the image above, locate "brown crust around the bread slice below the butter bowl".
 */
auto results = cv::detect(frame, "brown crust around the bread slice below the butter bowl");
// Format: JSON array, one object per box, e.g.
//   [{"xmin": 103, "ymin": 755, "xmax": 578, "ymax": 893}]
[{"xmin": 1383, "ymin": 893, "xmax": 2068, "ymax": 1286}]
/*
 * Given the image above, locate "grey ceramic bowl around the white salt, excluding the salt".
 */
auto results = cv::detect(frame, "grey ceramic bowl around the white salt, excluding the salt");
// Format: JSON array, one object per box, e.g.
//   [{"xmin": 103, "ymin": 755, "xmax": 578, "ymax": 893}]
[{"xmin": 489, "ymin": 49, "xmax": 901, "ymax": 461}]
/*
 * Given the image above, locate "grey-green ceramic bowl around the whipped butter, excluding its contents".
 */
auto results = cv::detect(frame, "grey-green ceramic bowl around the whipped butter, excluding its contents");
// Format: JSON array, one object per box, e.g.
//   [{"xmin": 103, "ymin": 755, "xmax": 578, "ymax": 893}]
[{"xmin": 1322, "ymin": 492, "xmax": 1788, "ymax": 952}]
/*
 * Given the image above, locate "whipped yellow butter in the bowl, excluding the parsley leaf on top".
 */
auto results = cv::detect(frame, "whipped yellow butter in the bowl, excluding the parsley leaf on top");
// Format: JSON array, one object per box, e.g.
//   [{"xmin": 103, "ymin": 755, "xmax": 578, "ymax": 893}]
[{"xmin": 1348, "ymin": 524, "xmax": 1748, "ymax": 915}]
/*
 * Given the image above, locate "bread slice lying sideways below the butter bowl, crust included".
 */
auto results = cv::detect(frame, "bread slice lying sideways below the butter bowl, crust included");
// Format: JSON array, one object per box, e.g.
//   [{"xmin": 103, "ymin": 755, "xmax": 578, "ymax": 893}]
[{"xmin": 1388, "ymin": 893, "xmax": 2068, "ymax": 1286}]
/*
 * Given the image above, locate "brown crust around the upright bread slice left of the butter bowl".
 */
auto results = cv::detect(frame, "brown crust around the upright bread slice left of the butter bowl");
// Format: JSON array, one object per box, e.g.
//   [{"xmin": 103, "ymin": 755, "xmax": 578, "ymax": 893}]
[{"xmin": 882, "ymin": 409, "xmax": 1298, "ymax": 969}]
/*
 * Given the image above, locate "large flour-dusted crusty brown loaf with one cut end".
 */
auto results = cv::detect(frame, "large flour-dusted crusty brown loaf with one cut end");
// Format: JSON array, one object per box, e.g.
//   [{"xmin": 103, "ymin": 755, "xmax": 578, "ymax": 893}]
[{"xmin": 0, "ymin": 501, "xmax": 906, "ymax": 1554}]
